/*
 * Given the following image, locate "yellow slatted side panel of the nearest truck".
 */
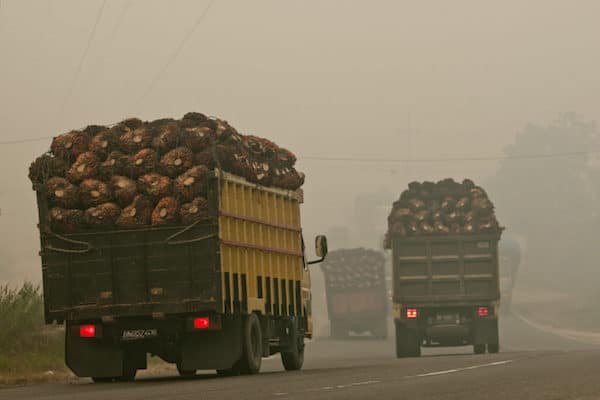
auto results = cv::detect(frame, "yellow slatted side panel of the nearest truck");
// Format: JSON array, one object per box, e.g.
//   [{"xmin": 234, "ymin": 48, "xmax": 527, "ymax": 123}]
[{"xmin": 219, "ymin": 174, "xmax": 310, "ymax": 330}]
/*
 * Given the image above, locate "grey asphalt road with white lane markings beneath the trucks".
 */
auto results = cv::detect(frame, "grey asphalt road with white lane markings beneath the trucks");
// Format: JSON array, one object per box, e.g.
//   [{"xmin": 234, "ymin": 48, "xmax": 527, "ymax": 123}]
[{"xmin": 0, "ymin": 317, "xmax": 600, "ymax": 400}]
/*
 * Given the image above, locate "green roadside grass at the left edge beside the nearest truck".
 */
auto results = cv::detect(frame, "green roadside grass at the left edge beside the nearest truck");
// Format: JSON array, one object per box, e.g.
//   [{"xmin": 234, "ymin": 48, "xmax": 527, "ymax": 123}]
[{"xmin": 0, "ymin": 283, "xmax": 66, "ymax": 384}]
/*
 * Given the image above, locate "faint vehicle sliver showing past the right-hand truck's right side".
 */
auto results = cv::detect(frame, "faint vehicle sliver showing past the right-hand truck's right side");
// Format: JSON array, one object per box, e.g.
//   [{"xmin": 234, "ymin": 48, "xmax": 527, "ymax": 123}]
[{"xmin": 499, "ymin": 234, "xmax": 521, "ymax": 314}]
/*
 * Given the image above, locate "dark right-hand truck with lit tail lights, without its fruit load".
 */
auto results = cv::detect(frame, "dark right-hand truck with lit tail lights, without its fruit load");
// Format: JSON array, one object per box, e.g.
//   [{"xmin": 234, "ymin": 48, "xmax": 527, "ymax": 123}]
[{"xmin": 391, "ymin": 231, "xmax": 501, "ymax": 358}]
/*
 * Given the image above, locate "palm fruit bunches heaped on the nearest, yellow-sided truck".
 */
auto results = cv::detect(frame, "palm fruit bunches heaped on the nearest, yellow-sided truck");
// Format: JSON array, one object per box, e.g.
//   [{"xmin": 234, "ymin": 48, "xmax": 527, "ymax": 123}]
[{"xmin": 29, "ymin": 112, "xmax": 304, "ymax": 232}]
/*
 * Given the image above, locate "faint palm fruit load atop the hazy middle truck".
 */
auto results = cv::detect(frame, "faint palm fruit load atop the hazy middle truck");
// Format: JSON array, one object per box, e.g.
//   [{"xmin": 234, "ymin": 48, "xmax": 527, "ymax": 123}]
[{"xmin": 321, "ymin": 248, "xmax": 385, "ymax": 289}]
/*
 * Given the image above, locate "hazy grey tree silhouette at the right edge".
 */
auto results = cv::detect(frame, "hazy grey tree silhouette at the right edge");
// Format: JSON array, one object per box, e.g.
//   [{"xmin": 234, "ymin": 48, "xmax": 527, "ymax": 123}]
[{"xmin": 486, "ymin": 113, "xmax": 600, "ymax": 289}]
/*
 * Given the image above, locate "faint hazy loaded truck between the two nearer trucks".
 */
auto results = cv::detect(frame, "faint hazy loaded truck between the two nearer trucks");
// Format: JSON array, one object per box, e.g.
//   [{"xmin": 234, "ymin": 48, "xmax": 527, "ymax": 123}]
[{"xmin": 321, "ymin": 248, "xmax": 389, "ymax": 339}]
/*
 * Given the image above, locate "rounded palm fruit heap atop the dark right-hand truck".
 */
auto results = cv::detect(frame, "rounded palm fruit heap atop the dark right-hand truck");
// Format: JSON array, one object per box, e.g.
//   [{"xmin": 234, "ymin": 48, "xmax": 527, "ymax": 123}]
[{"xmin": 384, "ymin": 179, "xmax": 502, "ymax": 248}]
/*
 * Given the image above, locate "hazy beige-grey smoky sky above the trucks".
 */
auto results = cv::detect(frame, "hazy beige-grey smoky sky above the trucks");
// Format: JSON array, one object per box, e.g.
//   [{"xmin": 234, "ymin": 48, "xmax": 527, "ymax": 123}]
[{"xmin": 0, "ymin": 0, "xmax": 600, "ymax": 281}]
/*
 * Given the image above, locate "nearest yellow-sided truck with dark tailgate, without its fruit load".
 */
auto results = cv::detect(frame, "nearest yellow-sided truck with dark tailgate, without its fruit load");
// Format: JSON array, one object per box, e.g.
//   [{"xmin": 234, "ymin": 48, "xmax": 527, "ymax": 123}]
[{"xmin": 36, "ymin": 170, "xmax": 327, "ymax": 382}]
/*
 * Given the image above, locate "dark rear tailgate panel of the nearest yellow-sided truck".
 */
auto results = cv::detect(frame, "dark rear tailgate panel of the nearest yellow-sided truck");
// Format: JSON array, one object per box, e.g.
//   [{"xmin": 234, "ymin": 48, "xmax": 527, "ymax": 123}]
[{"xmin": 42, "ymin": 224, "xmax": 221, "ymax": 322}]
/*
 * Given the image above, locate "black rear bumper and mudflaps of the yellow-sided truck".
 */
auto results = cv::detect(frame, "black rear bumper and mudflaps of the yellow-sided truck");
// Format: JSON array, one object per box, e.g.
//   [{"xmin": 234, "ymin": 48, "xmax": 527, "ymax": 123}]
[{"xmin": 65, "ymin": 316, "xmax": 242, "ymax": 378}]
